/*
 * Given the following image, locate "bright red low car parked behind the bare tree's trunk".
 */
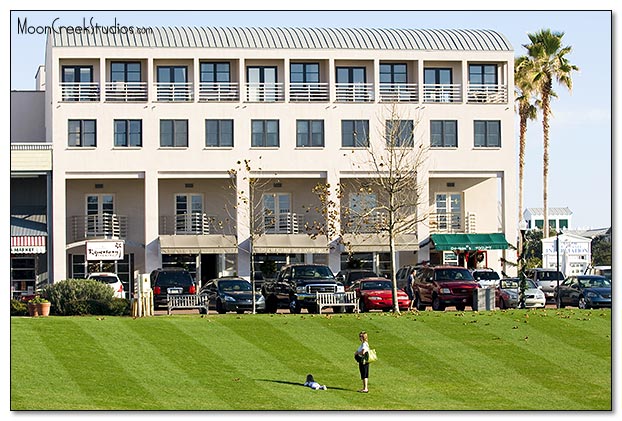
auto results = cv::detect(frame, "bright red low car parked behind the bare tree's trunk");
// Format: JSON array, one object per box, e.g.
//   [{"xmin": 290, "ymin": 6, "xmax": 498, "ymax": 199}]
[{"xmin": 350, "ymin": 277, "xmax": 410, "ymax": 313}]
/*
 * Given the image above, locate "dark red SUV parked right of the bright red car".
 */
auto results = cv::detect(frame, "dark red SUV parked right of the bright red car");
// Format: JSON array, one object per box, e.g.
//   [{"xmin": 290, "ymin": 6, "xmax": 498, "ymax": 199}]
[{"xmin": 413, "ymin": 266, "xmax": 478, "ymax": 311}]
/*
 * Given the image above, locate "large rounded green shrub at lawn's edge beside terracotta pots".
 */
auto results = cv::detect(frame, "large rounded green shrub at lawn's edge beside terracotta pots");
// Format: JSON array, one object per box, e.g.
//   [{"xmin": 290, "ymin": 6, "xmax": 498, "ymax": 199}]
[{"xmin": 41, "ymin": 279, "xmax": 129, "ymax": 316}]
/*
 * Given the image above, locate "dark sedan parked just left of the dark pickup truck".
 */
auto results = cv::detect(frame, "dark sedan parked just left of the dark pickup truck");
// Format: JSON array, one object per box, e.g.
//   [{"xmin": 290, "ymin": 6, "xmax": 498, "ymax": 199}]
[{"xmin": 200, "ymin": 277, "xmax": 266, "ymax": 314}]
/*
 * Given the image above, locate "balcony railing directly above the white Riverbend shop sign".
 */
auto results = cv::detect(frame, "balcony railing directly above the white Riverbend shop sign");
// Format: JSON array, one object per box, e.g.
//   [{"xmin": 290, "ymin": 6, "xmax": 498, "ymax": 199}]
[{"xmin": 70, "ymin": 213, "xmax": 127, "ymax": 241}]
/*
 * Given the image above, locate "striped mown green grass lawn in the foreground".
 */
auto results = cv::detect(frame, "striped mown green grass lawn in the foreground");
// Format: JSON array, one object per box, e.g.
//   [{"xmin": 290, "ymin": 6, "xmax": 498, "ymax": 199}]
[{"xmin": 11, "ymin": 309, "xmax": 612, "ymax": 410}]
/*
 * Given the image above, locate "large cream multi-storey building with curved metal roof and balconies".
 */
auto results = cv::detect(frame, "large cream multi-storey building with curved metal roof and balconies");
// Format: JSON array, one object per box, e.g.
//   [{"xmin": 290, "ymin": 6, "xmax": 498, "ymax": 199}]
[{"xmin": 40, "ymin": 28, "xmax": 517, "ymax": 292}]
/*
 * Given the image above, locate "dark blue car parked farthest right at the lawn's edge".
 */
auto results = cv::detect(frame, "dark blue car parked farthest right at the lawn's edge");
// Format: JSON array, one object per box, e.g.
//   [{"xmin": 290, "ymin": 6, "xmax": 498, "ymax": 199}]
[{"xmin": 555, "ymin": 275, "xmax": 611, "ymax": 308}]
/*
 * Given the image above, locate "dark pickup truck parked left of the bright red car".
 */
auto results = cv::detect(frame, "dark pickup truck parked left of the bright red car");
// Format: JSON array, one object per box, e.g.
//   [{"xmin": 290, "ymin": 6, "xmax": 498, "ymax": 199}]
[{"xmin": 261, "ymin": 263, "xmax": 344, "ymax": 314}]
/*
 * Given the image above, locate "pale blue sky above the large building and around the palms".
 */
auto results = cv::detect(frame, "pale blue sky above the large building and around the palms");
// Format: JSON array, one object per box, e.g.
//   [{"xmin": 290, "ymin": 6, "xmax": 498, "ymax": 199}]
[{"xmin": 5, "ymin": 4, "xmax": 614, "ymax": 228}]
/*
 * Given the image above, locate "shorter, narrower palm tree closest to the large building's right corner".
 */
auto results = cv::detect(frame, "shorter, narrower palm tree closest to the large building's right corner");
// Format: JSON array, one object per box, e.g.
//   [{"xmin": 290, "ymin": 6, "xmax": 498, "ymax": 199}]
[{"xmin": 514, "ymin": 56, "xmax": 539, "ymax": 256}]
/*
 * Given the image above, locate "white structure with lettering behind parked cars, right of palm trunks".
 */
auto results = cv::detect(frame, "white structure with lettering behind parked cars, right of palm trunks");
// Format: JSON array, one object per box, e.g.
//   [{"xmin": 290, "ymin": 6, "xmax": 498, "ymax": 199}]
[{"xmin": 542, "ymin": 233, "xmax": 592, "ymax": 276}]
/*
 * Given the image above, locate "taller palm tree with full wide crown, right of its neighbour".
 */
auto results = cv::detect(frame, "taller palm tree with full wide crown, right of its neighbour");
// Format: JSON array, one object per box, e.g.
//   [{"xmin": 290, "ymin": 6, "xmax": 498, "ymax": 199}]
[{"xmin": 523, "ymin": 29, "xmax": 579, "ymax": 238}]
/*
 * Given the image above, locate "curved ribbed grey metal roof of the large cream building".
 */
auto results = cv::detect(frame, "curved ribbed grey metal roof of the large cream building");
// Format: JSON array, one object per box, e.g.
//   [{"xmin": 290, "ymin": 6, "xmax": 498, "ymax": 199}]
[{"xmin": 48, "ymin": 27, "xmax": 513, "ymax": 51}]
